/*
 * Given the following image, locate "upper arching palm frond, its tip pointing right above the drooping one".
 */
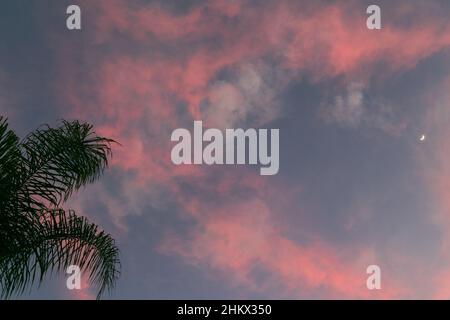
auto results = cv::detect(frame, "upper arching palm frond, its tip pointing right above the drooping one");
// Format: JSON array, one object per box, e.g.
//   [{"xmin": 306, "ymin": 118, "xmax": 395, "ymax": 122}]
[{"xmin": 18, "ymin": 121, "xmax": 114, "ymax": 208}]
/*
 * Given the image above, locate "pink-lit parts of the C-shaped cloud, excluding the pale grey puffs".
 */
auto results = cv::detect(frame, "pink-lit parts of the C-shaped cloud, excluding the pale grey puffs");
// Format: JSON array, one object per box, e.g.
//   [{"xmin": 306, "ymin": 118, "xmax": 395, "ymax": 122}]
[{"xmin": 48, "ymin": 0, "xmax": 450, "ymax": 298}]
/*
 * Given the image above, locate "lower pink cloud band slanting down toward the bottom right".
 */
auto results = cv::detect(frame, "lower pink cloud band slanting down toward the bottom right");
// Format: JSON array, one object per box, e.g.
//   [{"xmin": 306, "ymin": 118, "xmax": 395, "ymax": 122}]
[{"xmin": 160, "ymin": 200, "xmax": 404, "ymax": 299}]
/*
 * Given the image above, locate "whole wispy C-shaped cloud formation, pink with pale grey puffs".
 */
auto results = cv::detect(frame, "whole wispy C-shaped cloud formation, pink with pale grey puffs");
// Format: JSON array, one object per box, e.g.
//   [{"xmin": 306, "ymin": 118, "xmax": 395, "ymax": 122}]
[{"xmin": 22, "ymin": 0, "xmax": 450, "ymax": 298}]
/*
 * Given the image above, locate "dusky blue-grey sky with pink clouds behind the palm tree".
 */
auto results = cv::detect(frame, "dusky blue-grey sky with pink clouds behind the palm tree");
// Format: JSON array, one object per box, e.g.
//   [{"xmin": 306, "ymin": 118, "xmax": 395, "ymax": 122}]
[{"xmin": 0, "ymin": 0, "xmax": 450, "ymax": 299}]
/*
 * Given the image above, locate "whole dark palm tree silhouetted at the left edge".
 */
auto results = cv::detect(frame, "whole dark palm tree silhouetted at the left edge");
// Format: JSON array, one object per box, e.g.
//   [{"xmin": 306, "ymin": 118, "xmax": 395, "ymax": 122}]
[{"xmin": 0, "ymin": 116, "xmax": 120, "ymax": 298}]
